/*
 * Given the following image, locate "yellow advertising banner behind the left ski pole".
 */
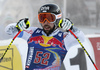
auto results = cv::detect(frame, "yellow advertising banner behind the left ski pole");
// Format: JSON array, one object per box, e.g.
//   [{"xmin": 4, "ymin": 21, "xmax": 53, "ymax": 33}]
[{"xmin": 0, "ymin": 45, "xmax": 22, "ymax": 70}]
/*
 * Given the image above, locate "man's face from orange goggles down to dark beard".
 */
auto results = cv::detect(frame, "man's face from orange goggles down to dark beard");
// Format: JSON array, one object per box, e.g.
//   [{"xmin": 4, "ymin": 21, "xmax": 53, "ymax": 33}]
[{"xmin": 38, "ymin": 12, "xmax": 56, "ymax": 35}]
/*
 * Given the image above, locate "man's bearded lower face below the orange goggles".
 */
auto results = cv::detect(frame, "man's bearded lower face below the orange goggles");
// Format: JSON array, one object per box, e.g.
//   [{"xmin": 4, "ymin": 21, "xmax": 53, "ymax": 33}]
[{"xmin": 41, "ymin": 21, "xmax": 54, "ymax": 34}]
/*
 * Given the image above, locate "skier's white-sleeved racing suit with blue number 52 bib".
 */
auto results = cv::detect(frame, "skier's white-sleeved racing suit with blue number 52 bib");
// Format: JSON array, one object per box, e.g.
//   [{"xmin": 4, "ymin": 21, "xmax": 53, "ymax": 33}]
[{"xmin": 5, "ymin": 24, "xmax": 84, "ymax": 70}]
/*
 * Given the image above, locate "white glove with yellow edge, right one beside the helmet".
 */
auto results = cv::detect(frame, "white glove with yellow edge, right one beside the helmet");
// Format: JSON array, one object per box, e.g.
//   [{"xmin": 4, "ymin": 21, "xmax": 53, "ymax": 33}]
[{"xmin": 58, "ymin": 18, "xmax": 73, "ymax": 31}]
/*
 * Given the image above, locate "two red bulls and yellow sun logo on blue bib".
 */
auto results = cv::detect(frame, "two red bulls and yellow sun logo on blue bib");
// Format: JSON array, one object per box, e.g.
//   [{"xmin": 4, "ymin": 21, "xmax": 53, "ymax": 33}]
[{"xmin": 28, "ymin": 35, "xmax": 65, "ymax": 50}]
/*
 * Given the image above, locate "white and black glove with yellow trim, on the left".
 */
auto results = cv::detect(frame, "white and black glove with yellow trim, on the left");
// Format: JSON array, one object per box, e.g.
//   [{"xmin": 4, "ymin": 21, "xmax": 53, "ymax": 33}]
[{"xmin": 16, "ymin": 18, "xmax": 30, "ymax": 31}]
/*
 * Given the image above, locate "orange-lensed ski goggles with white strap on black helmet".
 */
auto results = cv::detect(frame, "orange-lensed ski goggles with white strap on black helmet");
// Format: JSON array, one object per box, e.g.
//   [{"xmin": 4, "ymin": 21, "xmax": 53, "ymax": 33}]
[{"xmin": 38, "ymin": 13, "xmax": 62, "ymax": 23}]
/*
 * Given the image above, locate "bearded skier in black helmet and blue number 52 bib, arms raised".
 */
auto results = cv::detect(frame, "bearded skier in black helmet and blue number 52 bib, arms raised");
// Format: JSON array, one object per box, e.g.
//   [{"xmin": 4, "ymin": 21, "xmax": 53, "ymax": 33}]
[{"xmin": 6, "ymin": 4, "xmax": 85, "ymax": 70}]
